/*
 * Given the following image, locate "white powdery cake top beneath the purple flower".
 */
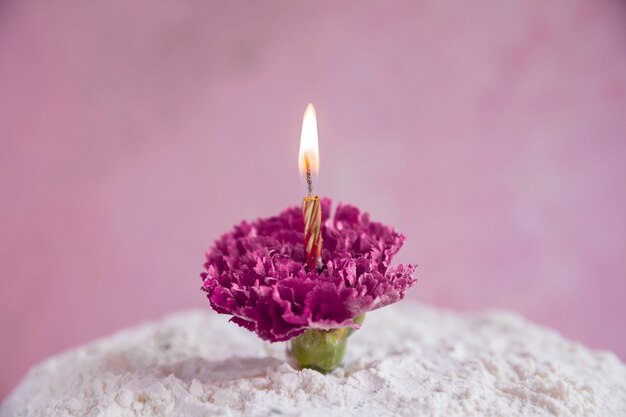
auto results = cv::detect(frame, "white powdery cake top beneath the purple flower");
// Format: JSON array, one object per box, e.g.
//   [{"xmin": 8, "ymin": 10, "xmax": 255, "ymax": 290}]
[{"xmin": 0, "ymin": 303, "xmax": 626, "ymax": 417}]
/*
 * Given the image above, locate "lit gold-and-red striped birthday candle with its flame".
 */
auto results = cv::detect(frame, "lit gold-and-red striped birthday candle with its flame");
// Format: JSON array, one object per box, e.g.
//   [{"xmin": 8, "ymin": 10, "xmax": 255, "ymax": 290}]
[{"xmin": 298, "ymin": 103, "xmax": 322, "ymax": 270}]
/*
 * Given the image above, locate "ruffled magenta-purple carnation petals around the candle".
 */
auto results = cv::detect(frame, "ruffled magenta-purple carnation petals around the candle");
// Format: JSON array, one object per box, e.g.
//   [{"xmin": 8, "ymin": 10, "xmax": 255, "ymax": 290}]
[{"xmin": 201, "ymin": 199, "xmax": 416, "ymax": 342}]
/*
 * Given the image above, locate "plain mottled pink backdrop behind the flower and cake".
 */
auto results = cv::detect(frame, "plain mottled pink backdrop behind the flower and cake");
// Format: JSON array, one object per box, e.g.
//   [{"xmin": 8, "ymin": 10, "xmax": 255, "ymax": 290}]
[{"xmin": 0, "ymin": 0, "xmax": 626, "ymax": 398}]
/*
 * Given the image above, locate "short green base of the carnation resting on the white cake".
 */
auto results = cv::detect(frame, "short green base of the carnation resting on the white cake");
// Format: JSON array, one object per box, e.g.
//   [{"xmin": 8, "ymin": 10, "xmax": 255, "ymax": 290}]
[{"xmin": 289, "ymin": 314, "xmax": 365, "ymax": 374}]
